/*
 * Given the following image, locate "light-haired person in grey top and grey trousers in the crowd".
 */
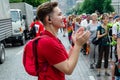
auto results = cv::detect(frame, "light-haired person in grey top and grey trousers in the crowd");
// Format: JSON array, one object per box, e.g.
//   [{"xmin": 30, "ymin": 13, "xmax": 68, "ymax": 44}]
[{"xmin": 87, "ymin": 13, "xmax": 100, "ymax": 69}]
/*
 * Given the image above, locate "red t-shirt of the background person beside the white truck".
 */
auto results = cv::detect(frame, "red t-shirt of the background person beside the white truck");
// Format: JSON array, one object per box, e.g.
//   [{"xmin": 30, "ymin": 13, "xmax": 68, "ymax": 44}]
[{"xmin": 30, "ymin": 21, "xmax": 45, "ymax": 37}]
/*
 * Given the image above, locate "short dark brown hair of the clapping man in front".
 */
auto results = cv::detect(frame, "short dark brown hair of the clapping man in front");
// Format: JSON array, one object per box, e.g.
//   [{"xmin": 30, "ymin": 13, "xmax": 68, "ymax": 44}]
[{"xmin": 37, "ymin": 2, "xmax": 58, "ymax": 24}]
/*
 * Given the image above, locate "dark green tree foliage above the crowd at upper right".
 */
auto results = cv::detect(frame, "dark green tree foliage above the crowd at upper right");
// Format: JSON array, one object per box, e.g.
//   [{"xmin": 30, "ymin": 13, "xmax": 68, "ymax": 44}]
[{"xmin": 70, "ymin": 0, "xmax": 114, "ymax": 14}]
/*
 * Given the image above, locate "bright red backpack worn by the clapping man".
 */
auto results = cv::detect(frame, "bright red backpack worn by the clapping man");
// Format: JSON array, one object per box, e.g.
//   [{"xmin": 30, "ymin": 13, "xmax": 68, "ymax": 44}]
[{"xmin": 23, "ymin": 35, "xmax": 47, "ymax": 76}]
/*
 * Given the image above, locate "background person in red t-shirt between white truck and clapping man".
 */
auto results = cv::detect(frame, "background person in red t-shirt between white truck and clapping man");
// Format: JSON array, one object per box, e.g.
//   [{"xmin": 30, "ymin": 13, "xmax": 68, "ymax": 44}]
[{"xmin": 30, "ymin": 17, "xmax": 44, "ymax": 37}]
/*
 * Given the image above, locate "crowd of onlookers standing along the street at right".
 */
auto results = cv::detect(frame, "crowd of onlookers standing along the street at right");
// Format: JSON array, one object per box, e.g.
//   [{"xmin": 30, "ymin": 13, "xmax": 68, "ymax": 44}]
[{"xmin": 59, "ymin": 12, "xmax": 120, "ymax": 80}]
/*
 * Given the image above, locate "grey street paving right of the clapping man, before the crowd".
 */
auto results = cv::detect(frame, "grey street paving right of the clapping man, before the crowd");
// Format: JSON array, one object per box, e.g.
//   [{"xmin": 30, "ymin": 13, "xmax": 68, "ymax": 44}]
[{"xmin": 58, "ymin": 30, "xmax": 111, "ymax": 80}]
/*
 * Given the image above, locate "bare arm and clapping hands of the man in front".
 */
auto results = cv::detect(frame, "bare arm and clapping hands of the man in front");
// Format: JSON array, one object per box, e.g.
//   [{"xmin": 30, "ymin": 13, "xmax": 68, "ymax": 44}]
[{"xmin": 54, "ymin": 28, "xmax": 90, "ymax": 75}]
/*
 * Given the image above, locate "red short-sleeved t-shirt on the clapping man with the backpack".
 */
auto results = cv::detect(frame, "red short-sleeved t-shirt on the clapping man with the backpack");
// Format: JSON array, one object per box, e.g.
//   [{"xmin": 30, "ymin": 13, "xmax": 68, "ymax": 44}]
[{"xmin": 37, "ymin": 30, "xmax": 68, "ymax": 80}]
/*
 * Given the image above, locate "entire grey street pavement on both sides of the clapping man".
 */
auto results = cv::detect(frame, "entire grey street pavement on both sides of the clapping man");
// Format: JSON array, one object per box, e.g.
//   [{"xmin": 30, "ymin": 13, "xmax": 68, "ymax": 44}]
[{"xmin": 0, "ymin": 28, "xmax": 111, "ymax": 80}]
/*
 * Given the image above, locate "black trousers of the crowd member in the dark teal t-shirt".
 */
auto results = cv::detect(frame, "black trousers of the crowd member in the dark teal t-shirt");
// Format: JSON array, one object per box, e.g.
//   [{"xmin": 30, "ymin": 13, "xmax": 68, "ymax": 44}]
[{"xmin": 96, "ymin": 45, "xmax": 109, "ymax": 68}]
